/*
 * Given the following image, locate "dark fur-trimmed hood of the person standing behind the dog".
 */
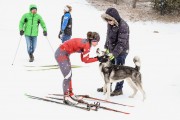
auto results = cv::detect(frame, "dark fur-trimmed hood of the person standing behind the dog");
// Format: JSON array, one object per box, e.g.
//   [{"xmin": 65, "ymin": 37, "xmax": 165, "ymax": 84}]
[{"xmin": 101, "ymin": 8, "xmax": 121, "ymax": 26}]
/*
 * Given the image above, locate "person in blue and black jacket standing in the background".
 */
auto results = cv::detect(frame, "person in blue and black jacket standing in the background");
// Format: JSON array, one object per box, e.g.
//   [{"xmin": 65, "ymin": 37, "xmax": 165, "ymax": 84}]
[{"xmin": 58, "ymin": 5, "xmax": 72, "ymax": 43}]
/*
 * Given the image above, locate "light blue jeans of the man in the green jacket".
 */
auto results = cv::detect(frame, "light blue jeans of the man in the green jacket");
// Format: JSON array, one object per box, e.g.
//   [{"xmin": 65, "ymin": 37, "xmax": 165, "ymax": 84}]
[{"xmin": 25, "ymin": 36, "xmax": 37, "ymax": 54}]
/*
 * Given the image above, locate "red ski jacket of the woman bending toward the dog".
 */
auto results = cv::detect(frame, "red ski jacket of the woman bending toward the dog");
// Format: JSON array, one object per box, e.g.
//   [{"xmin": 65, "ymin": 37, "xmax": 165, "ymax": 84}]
[{"xmin": 60, "ymin": 38, "xmax": 98, "ymax": 63}]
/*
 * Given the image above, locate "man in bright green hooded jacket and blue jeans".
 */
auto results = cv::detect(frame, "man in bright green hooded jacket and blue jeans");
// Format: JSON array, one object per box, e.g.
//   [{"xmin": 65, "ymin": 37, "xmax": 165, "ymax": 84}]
[{"xmin": 19, "ymin": 4, "xmax": 47, "ymax": 62}]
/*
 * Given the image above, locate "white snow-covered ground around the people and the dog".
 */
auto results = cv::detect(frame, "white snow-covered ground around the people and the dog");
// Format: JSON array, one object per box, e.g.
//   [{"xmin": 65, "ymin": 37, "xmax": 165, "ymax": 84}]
[{"xmin": 0, "ymin": 0, "xmax": 180, "ymax": 120}]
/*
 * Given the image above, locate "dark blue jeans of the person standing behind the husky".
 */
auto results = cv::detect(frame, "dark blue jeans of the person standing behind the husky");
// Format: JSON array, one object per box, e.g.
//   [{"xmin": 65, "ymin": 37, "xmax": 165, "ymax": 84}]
[{"xmin": 115, "ymin": 54, "xmax": 127, "ymax": 90}]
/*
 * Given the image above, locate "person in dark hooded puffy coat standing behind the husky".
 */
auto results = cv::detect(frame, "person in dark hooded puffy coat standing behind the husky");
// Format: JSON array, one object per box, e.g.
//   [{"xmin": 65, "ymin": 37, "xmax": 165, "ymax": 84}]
[{"xmin": 97, "ymin": 8, "xmax": 129, "ymax": 96}]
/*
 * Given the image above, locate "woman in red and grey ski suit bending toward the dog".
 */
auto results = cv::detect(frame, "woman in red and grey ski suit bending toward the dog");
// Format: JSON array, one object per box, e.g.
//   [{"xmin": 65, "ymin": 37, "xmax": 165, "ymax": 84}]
[{"xmin": 55, "ymin": 32, "xmax": 106, "ymax": 105}]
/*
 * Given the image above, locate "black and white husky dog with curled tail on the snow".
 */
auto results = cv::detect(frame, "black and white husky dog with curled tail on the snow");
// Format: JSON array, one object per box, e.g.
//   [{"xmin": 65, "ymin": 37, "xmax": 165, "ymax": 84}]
[{"xmin": 96, "ymin": 48, "xmax": 146, "ymax": 101}]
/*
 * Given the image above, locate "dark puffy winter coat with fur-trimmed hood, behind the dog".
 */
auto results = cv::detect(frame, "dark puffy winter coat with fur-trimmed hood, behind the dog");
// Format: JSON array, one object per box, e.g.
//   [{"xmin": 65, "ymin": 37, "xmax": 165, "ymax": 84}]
[{"xmin": 101, "ymin": 8, "xmax": 129, "ymax": 57}]
